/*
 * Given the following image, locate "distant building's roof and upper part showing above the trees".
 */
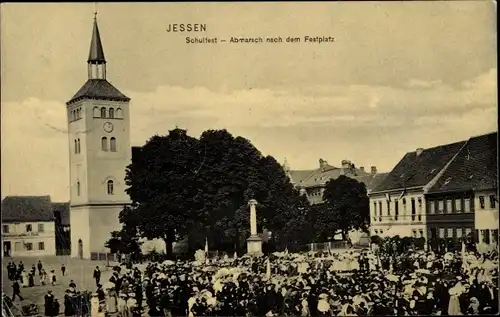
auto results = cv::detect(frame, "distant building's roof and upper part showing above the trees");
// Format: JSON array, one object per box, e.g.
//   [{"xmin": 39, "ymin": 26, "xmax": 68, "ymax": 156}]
[{"xmin": 283, "ymin": 159, "xmax": 386, "ymax": 204}]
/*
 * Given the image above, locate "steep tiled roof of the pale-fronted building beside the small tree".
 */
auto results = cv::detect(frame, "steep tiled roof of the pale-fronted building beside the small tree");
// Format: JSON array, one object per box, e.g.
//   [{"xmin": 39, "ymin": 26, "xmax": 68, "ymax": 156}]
[{"xmin": 373, "ymin": 141, "xmax": 466, "ymax": 192}]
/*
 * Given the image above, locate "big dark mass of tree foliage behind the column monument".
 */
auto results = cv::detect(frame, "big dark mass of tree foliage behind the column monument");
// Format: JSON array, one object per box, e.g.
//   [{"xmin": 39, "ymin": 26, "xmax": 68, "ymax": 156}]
[{"xmin": 121, "ymin": 129, "xmax": 309, "ymax": 254}]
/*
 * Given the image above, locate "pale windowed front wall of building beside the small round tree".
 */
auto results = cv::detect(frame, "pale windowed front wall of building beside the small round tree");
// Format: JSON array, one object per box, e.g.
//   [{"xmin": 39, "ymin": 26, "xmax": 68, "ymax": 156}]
[{"xmin": 370, "ymin": 190, "xmax": 427, "ymax": 238}]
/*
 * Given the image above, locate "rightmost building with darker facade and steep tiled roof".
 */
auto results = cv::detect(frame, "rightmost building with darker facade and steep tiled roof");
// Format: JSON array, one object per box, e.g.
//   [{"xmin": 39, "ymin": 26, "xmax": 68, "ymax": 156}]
[{"xmin": 426, "ymin": 132, "xmax": 498, "ymax": 248}]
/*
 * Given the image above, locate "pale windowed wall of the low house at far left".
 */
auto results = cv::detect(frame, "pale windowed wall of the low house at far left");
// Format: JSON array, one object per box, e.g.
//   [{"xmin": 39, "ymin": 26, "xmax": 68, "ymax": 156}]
[{"xmin": 2, "ymin": 221, "xmax": 56, "ymax": 257}]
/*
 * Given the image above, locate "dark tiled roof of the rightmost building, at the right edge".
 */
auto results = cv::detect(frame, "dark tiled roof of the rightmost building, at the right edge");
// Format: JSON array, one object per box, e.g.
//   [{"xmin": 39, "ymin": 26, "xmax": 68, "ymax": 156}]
[{"xmin": 429, "ymin": 132, "xmax": 498, "ymax": 193}]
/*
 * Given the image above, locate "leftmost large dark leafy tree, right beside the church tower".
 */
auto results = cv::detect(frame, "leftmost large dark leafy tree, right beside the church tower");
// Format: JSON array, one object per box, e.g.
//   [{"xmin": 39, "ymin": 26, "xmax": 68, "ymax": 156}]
[{"xmin": 125, "ymin": 129, "xmax": 200, "ymax": 255}]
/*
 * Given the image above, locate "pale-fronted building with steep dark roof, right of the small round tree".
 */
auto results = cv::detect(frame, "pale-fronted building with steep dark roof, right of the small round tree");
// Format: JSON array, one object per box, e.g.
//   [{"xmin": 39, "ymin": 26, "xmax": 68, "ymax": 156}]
[{"xmin": 369, "ymin": 141, "xmax": 465, "ymax": 238}]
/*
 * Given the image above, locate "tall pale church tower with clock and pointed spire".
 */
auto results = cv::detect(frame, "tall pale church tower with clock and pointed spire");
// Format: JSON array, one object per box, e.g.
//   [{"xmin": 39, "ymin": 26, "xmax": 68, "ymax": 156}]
[{"xmin": 66, "ymin": 13, "xmax": 131, "ymax": 259}]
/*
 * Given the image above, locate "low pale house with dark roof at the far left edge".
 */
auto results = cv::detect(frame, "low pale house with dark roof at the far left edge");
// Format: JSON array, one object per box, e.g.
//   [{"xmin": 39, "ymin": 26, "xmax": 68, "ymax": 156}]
[{"xmin": 2, "ymin": 196, "xmax": 56, "ymax": 257}]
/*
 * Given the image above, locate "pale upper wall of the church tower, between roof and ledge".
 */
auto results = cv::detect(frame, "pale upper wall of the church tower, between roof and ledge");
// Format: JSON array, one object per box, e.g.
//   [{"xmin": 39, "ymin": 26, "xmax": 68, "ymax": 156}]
[{"xmin": 68, "ymin": 100, "xmax": 132, "ymax": 205}]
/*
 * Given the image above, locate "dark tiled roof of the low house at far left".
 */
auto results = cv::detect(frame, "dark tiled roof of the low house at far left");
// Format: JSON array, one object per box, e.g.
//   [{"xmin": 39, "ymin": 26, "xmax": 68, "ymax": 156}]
[{"xmin": 2, "ymin": 196, "xmax": 54, "ymax": 222}]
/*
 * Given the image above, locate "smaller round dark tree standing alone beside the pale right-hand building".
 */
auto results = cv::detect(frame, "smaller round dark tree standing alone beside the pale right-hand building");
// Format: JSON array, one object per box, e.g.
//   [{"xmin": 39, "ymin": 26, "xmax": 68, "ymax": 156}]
[{"xmin": 315, "ymin": 175, "xmax": 370, "ymax": 239}]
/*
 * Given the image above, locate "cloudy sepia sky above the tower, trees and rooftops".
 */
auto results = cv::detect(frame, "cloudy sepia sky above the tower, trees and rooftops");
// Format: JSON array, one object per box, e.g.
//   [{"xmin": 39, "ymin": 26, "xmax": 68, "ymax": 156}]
[{"xmin": 0, "ymin": 1, "xmax": 498, "ymax": 201}]
